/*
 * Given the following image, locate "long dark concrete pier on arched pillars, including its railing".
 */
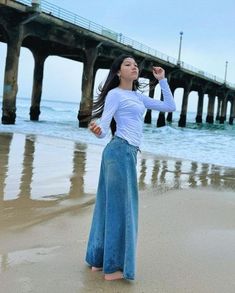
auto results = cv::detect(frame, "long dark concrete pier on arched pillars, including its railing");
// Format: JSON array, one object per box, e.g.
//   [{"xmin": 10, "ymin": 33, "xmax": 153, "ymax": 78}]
[{"xmin": 0, "ymin": 0, "xmax": 235, "ymax": 127}]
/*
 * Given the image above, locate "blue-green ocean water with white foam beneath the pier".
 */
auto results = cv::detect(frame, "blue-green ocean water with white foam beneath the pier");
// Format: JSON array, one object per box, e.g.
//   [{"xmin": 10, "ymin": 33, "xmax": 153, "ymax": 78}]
[{"xmin": 0, "ymin": 98, "xmax": 235, "ymax": 168}]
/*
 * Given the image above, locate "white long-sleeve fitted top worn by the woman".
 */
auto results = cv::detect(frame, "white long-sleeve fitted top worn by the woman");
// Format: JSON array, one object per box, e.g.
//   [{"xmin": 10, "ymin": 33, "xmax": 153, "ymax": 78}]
[{"xmin": 98, "ymin": 78, "xmax": 176, "ymax": 147}]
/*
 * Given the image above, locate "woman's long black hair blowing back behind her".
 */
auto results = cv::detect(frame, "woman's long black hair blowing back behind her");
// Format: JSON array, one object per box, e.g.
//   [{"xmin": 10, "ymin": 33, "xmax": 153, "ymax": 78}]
[{"xmin": 92, "ymin": 54, "xmax": 140, "ymax": 135}]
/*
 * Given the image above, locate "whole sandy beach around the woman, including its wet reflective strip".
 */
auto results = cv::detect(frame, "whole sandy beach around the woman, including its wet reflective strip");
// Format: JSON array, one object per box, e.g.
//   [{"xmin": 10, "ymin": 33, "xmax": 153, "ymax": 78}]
[{"xmin": 0, "ymin": 134, "xmax": 235, "ymax": 293}]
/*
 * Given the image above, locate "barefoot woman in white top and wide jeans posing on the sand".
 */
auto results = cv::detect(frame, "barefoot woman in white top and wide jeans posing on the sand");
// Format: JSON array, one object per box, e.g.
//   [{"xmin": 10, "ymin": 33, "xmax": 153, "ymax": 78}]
[{"xmin": 86, "ymin": 55, "xmax": 175, "ymax": 280}]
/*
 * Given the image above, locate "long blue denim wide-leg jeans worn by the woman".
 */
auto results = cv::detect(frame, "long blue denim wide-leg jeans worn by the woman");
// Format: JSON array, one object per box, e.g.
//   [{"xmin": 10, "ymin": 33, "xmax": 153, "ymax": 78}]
[{"xmin": 86, "ymin": 136, "xmax": 138, "ymax": 280}]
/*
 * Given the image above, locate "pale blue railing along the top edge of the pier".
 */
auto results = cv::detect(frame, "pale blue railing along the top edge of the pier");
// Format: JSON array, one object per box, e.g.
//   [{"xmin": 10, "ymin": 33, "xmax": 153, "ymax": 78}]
[{"xmin": 16, "ymin": 0, "xmax": 235, "ymax": 88}]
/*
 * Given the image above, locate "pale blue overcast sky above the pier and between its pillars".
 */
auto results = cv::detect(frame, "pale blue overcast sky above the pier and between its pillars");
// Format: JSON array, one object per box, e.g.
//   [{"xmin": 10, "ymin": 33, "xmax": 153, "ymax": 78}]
[{"xmin": 0, "ymin": 0, "xmax": 235, "ymax": 107}]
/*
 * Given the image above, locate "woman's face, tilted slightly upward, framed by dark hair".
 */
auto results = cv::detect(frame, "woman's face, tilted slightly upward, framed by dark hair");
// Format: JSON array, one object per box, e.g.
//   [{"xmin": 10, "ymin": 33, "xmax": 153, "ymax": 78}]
[{"xmin": 118, "ymin": 57, "xmax": 139, "ymax": 81}]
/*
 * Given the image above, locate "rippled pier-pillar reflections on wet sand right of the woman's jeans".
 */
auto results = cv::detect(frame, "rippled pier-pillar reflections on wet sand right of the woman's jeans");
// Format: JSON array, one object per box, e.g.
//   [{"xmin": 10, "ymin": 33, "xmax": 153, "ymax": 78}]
[{"xmin": 139, "ymin": 157, "xmax": 235, "ymax": 192}]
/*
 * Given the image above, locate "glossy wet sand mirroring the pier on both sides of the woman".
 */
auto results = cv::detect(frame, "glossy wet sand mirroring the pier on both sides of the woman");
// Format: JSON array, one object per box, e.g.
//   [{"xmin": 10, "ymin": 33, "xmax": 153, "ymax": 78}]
[{"xmin": 0, "ymin": 134, "xmax": 235, "ymax": 244}]
